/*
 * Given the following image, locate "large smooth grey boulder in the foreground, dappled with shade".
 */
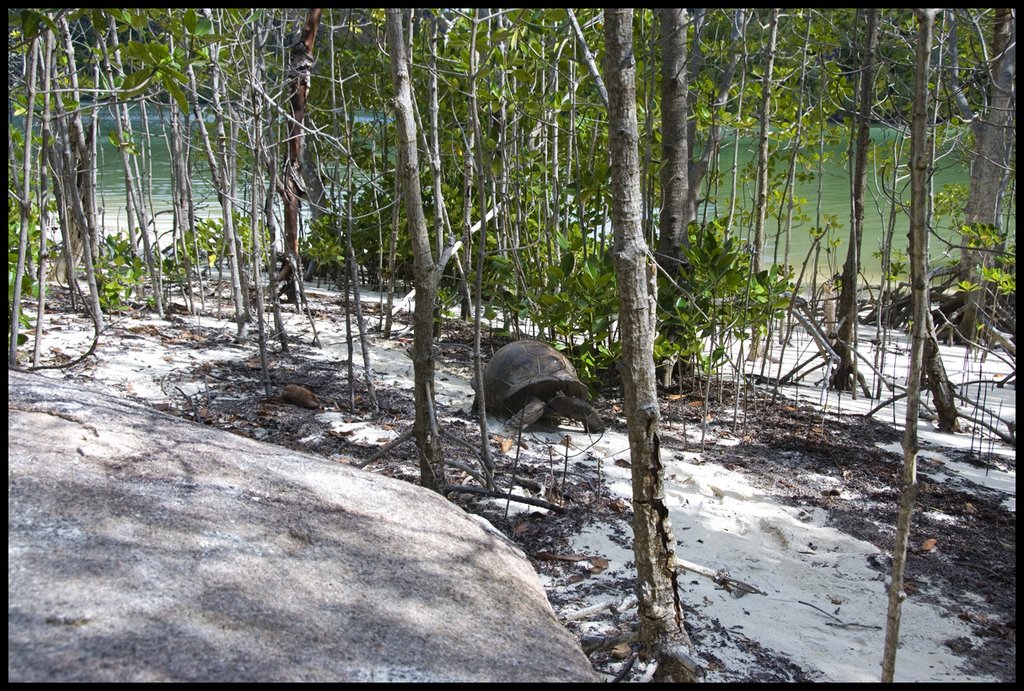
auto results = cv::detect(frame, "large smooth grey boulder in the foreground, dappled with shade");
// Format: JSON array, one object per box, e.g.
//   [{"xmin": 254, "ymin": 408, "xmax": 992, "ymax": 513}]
[{"xmin": 7, "ymin": 372, "xmax": 595, "ymax": 682}]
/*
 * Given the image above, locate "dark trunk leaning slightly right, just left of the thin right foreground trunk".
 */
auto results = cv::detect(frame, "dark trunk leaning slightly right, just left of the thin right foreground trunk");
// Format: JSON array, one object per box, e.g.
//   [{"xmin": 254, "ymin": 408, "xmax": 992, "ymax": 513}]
[{"xmin": 831, "ymin": 8, "xmax": 881, "ymax": 393}]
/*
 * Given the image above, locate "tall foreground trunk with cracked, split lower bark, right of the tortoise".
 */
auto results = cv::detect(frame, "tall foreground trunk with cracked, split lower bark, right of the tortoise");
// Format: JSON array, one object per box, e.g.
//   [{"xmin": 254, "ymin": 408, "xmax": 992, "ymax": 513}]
[{"xmin": 604, "ymin": 8, "xmax": 697, "ymax": 682}]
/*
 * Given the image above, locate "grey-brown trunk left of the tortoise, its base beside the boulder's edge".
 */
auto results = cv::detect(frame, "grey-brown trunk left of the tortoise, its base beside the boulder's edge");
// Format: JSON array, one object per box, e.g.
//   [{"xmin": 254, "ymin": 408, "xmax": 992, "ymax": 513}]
[{"xmin": 387, "ymin": 8, "xmax": 445, "ymax": 491}]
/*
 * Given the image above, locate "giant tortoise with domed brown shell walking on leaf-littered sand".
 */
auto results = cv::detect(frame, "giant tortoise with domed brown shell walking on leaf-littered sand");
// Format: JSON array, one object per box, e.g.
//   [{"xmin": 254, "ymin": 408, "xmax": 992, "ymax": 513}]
[{"xmin": 483, "ymin": 340, "xmax": 604, "ymax": 432}]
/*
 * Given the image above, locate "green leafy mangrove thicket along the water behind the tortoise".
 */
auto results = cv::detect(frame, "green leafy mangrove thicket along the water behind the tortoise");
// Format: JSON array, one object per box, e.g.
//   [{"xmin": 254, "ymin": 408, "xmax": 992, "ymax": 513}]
[{"xmin": 8, "ymin": 8, "xmax": 1016, "ymax": 395}]
